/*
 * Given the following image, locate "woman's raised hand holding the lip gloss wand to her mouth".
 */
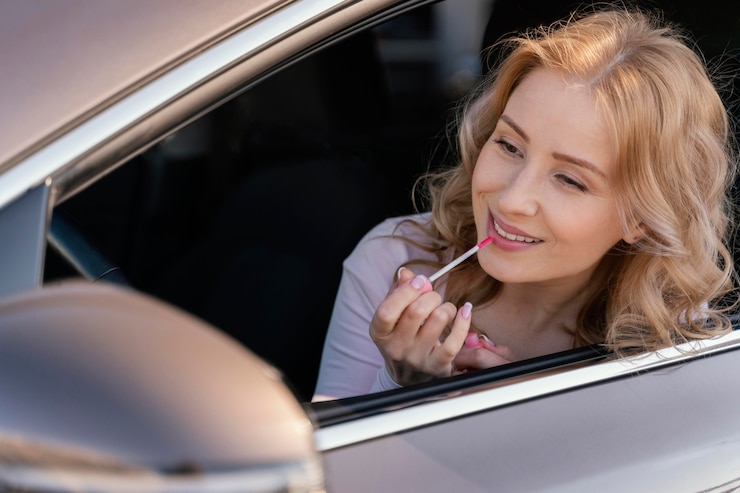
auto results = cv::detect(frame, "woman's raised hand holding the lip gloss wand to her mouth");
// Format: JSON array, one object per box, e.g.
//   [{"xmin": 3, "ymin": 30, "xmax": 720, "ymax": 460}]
[{"xmin": 370, "ymin": 268, "xmax": 472, "ymax": 385}]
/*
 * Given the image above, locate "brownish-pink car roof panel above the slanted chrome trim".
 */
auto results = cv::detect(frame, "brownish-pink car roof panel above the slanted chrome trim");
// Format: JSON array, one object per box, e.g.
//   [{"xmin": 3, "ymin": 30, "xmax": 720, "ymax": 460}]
[{"xmin": 0, "ymin": 0, "xmax": 291, "ymax": 172}]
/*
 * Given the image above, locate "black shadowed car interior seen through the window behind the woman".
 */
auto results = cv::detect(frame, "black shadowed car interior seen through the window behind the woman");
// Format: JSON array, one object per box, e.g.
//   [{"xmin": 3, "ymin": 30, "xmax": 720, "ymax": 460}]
[{"xmin": 46, "ymin": 0, "xmax": 737, "ymax": 400}]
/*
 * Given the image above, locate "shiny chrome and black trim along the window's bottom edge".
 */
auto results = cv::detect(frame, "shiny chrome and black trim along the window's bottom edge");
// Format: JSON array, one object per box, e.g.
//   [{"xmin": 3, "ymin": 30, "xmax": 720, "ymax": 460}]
[{"xmin": 313, "ymin": 330, "xmax": 740, "ymax": 452}]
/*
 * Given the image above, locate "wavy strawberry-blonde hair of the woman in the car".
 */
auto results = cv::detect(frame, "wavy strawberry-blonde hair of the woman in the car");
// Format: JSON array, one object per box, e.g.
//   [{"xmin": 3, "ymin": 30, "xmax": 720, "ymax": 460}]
[{"xmin": 414, "ymin": 9, "xmax": 735, "ymax": 353}]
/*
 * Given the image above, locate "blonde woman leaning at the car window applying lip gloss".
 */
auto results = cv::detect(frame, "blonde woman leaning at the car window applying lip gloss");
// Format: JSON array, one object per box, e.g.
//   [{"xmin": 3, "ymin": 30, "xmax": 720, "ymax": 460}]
[{"xmin": 316, "ymin": 9, "xmax": 735, "ymax": 399}]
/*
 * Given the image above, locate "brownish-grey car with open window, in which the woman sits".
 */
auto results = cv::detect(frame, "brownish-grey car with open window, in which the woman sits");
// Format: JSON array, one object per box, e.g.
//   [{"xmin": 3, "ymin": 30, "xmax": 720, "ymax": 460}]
[{"xmin": 0, "ymin": 0, "xmax": 740, "ymax": 493}]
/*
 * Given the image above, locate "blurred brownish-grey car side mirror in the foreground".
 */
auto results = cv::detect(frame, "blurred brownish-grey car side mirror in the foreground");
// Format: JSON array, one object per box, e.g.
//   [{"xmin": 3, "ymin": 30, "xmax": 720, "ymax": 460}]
[{"xmin": 0, "ymin": 281, "xmax": 323, "ymax": 492}]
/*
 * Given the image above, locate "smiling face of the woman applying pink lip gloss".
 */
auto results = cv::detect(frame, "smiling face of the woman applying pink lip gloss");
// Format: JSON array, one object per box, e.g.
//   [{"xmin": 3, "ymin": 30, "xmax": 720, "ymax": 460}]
[{"xmin": 472, "ymin": 69, "xmax": 623, "ymax": 288}]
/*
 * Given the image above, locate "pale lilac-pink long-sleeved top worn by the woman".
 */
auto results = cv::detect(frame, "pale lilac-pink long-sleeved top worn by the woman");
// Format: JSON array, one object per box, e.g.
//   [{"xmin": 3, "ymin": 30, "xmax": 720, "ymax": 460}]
[{"xmin": 316, "ymin": 214, "xmax": 436, "ymax": 398}]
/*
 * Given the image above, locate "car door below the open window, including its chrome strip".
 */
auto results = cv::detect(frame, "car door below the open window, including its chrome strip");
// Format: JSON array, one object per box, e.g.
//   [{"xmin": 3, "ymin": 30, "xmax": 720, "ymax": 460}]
[{"xmin": 314, "ymin": 332, "xmax": 740, "ymax": 492}]
